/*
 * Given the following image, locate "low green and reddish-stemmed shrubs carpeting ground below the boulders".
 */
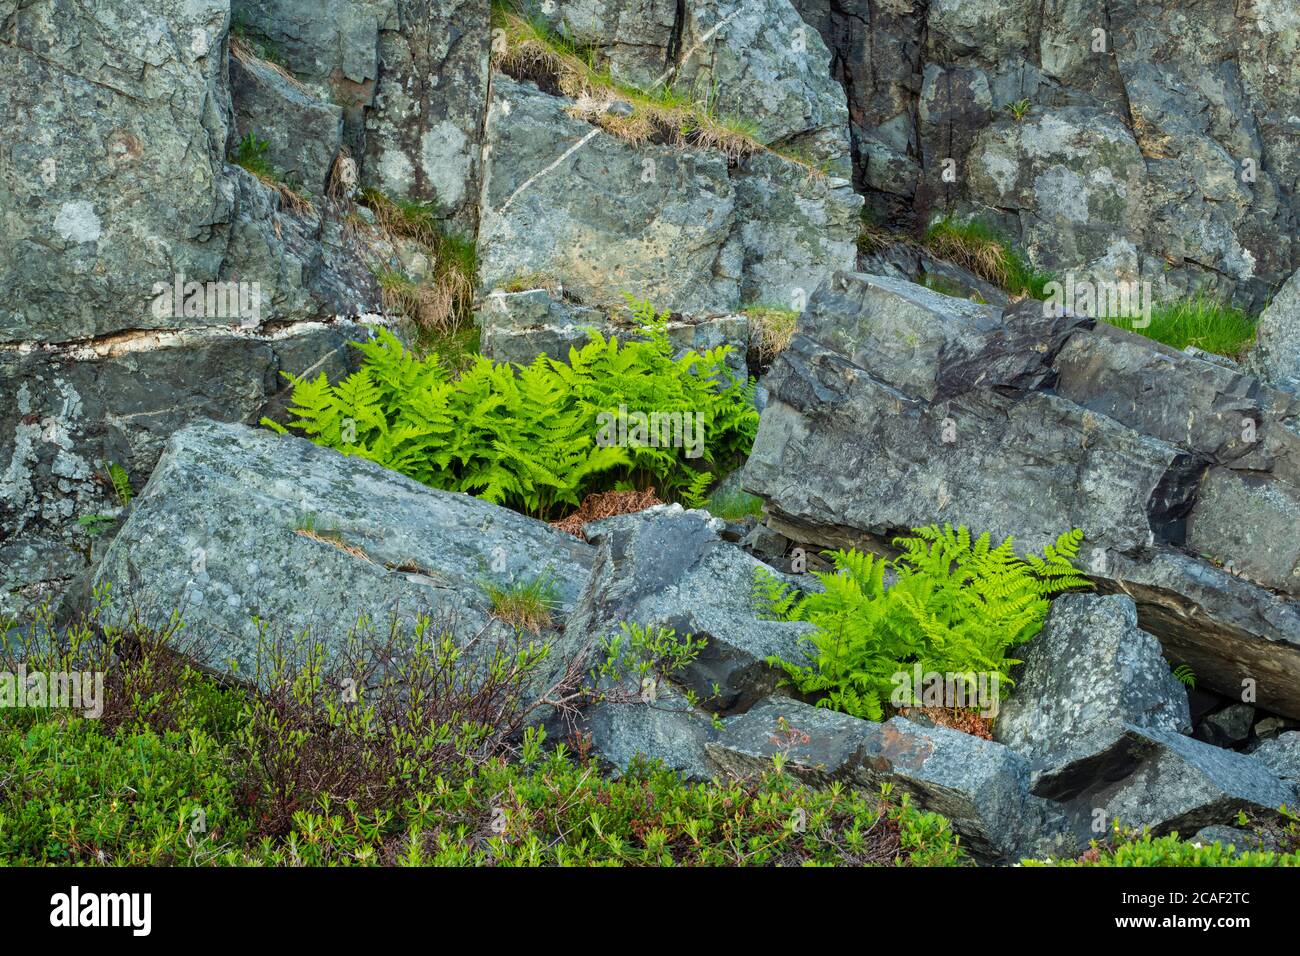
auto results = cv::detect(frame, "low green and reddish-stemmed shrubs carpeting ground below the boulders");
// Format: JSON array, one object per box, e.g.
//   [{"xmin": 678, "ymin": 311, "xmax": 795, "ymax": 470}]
[{"xmin": 0, "ymin": 600, "xmax": 969, "ymax": 866}]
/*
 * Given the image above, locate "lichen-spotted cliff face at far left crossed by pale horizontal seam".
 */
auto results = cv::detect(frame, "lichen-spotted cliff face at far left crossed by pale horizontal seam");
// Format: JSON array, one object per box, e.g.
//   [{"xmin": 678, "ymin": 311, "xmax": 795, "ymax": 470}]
[{"xmin": 0, "ymin": 0, "xmax": 395, "ymax": 611}]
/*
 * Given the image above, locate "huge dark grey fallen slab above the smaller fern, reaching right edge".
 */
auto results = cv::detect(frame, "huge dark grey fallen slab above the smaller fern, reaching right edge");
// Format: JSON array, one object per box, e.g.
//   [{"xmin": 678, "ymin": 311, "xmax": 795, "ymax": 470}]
[{"xmin": 744, "ymin": 274, "xmax": 1300, "ymax": 715}]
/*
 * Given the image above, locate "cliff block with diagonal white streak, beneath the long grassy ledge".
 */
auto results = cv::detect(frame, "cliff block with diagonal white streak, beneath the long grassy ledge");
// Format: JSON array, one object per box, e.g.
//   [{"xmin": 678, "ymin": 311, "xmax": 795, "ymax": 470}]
[{"xmin": 478, "ymin": 75, "xmax": 861, "ymax": 315}]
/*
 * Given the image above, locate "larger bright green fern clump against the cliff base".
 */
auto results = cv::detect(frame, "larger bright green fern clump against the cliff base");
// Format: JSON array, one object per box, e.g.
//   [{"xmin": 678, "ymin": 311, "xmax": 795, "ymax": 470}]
[{"xmin": 265, "ymin": 303, "xmax": 758, "ymax": 516}]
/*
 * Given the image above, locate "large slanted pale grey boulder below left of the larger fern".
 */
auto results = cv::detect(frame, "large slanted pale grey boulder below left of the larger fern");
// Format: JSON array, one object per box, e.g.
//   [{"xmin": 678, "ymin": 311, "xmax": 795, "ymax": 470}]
[{"xmin": 95, "ymin": 421, "xmax": 594, "ymax": 674}]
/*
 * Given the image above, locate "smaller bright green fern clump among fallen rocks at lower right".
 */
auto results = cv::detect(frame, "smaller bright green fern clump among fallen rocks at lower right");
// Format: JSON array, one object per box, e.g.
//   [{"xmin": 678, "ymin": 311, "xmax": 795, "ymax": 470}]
[{"xmin": 754, "ymin": 524, "xmax": 1091, "ymax": 721}]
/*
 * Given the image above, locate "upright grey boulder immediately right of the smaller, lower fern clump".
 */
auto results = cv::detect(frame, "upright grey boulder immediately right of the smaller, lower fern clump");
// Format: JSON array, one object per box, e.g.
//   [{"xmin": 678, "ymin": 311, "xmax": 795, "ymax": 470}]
[{"xmin": 995, "ymin": 594, "xmax": 1192, "ymax": 800}]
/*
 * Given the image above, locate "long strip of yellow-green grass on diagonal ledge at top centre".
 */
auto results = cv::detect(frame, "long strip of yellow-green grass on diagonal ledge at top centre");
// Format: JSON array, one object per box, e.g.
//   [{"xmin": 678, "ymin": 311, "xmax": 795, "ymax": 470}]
[{"xmin": 493, "ymin": 4, "xmax": 826, "ymax": 177}]
